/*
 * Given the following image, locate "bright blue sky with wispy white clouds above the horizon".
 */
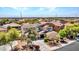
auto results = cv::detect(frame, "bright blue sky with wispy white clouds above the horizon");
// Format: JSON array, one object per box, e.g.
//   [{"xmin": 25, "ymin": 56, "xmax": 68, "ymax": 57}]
[{"xmin": 0, "ymin": 7, "xmax": 79, "ymax": 17}]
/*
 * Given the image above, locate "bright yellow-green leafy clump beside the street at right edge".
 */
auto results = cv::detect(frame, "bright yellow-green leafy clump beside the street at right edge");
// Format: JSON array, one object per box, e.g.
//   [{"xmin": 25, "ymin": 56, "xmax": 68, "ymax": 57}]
[{"xmin": 59, "ymin": 24, "xmax": 79, "ymax": 38}]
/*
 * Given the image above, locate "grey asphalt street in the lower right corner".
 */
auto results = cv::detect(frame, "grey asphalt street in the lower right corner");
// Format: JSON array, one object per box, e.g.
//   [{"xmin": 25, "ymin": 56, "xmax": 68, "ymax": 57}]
[{"xmin": 56, "ymin": 42, "xmax": 79, "ymax": 51}]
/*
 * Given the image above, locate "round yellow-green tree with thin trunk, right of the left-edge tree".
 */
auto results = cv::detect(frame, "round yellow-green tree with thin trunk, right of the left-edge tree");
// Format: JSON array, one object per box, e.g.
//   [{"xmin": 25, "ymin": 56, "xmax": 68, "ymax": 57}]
[{"xmin": 7, "ymin": 28, "xmax": 20, "ymax": 50}]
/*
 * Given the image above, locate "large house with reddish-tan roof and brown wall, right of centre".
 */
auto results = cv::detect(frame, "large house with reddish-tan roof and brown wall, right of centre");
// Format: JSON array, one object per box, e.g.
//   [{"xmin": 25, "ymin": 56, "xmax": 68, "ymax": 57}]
[{"xmin": 40, "ymin": 21, "xmax": 64, "ymax": 31}]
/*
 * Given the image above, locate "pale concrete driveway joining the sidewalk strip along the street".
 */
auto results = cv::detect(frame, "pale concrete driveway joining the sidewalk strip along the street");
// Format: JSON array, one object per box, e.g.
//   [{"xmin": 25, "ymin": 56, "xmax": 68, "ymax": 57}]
[{"xmin": 33, "ymin": 40, "xmax": 76, "ymax": 51}]
